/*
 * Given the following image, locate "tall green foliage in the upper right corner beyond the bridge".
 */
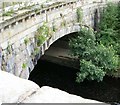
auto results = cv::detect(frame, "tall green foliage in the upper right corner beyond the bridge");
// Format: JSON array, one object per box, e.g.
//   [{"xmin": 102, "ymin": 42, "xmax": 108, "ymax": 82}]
[{"xmin": 97, "ymin": 3, "xmax": 120, "ymax": 55}]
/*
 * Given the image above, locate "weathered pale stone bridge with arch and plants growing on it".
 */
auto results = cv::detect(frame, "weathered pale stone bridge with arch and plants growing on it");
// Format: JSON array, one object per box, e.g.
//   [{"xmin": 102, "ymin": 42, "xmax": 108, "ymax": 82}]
[{"xmin": 0, "ymin": 1, "xmax": 116, "ymax": 78}]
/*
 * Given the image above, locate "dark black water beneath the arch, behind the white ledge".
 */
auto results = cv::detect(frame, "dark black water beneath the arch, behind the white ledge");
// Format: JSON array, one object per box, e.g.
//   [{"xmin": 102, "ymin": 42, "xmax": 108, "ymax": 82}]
[{"xmin": 29, "ymin": 60, "xmax": 120, "ymax": 103}]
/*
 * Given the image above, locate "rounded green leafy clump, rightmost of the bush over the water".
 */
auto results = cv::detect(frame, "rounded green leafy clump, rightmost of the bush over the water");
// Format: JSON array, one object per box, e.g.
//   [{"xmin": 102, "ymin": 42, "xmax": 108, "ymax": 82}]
[{"xmin": 88, "ymin": 44, "xmax": 118, "ymax": 73}]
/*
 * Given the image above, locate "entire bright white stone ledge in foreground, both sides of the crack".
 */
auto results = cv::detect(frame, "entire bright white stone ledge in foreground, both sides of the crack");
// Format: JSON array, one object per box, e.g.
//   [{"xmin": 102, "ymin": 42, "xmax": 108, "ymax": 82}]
[{"xmin": 0, "ymin": 70, "xmax": 102, "ymax": 104}]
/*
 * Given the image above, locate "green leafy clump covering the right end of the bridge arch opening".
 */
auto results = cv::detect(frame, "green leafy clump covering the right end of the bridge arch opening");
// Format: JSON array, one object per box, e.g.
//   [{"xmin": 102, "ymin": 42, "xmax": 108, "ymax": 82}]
[{"xmin": 69, "ymin": 28, "xmax": 95, "ymax": 58}]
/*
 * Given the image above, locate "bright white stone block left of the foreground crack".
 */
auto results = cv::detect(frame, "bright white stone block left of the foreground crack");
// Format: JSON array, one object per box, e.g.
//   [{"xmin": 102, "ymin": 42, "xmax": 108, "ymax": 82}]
[{"xmin": 0, "ymin": 70, "xmax": 39, "ymax": 103}]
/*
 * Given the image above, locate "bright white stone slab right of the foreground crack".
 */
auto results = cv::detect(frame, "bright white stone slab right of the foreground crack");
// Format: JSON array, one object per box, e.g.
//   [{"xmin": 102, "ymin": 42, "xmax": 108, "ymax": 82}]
[{"xmin": 24, "ymin": 86, "xmax": 100, "ymax": 103}]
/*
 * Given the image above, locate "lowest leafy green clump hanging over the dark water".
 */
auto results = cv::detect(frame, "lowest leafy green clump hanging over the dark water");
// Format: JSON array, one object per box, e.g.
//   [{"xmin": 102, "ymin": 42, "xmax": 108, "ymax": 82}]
[{"xmin": 76, "ymin": 59, "xmax": 105, "ymax": 83}]
